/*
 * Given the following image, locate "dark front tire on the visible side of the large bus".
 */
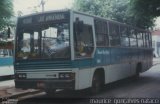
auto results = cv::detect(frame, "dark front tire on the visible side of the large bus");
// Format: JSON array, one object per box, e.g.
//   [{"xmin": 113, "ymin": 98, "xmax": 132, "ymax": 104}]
[{"xmin": 91, "ymin": 73, "xmax": 102, "ymax": 95}]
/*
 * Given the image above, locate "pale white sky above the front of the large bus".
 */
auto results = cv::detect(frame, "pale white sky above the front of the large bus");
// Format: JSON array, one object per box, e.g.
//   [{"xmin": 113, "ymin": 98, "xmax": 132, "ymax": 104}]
[{"xmin": 14, "ymin": 0, "xmax": 74, "ymax": 15}]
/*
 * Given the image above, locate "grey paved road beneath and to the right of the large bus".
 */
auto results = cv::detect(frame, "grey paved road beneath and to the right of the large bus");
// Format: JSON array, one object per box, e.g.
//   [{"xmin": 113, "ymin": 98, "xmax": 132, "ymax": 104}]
[{"xmin": 18, "ymin": 64, "xmax": 160, "ymax": 104}]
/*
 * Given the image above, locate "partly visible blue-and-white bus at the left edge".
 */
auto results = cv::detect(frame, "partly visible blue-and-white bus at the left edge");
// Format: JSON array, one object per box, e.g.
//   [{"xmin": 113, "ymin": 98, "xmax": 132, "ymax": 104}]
[{"xmin": 0, "ymin": 41, "xmax": 14, "ymax": 80}]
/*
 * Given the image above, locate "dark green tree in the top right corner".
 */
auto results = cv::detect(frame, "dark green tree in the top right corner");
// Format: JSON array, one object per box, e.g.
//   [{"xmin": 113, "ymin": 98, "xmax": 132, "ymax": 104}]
[{"xmin": 130, "ymin": 0, "xmax": 160, "ymax": 28}]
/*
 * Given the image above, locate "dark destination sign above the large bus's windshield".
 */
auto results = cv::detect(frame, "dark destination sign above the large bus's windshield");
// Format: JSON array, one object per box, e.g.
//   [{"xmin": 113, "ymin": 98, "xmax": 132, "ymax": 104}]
[{"xmin": 20, "ymin": 12, "xmax": 69, "ymax": 25}]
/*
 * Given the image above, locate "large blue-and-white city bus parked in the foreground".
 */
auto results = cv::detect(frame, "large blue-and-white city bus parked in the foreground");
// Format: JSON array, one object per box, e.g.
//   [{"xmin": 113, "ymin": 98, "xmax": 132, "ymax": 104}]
[{"xmin": 14, "ymin": 10, "xmax": 153, "ymax": 94}]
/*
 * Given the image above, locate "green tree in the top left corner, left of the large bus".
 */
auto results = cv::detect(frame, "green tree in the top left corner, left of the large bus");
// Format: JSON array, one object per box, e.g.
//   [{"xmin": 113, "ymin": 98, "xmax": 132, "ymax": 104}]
[{"xmin": 0, "ymin": 0, "xmax": 13, "ymax": 30}]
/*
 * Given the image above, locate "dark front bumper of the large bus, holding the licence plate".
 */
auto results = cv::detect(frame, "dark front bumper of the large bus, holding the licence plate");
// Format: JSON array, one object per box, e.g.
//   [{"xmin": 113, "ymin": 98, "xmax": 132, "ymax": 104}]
[{"xmin": 15, "ymin": 80, "xmax": 75, "ymax": 90}]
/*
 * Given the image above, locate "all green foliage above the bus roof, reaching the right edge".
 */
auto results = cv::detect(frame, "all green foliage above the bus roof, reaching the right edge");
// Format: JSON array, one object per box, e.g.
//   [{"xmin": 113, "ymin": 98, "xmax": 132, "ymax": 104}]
[{"xmin": 73, "ymin": 0, "xmax": 160, "ymax": 29}]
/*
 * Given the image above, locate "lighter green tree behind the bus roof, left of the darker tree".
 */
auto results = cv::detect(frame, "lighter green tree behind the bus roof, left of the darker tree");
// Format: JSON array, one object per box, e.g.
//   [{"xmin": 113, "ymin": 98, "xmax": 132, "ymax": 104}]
[{"xmin": 73, "ymin": 0, "xmax": 130, "ymax": 23}]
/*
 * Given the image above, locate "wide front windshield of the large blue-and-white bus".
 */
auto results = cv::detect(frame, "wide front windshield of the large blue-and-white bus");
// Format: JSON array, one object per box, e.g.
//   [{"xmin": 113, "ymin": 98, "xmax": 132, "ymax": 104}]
[{"xmin": 16, "ymin": 22, "xmax": 70, "ymax": 60}]
